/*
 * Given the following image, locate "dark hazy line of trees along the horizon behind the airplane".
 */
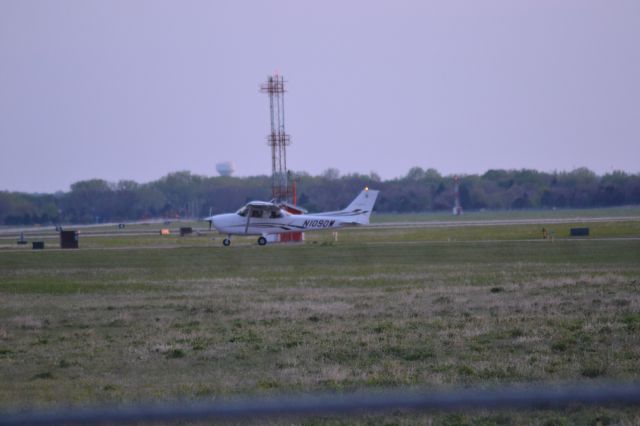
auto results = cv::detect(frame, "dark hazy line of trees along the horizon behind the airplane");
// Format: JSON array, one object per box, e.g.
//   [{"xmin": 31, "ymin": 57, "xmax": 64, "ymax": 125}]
[{"xmin": 0, "ymin": 167, "xmax": 640, "ymax": 225}]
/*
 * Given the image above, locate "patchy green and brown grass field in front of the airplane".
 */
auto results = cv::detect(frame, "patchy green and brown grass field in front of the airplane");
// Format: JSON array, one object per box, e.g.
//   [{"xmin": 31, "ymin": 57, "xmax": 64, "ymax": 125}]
[{"xmin": 0, "ymin": 220, "xmax": 640, "ymax": 425}]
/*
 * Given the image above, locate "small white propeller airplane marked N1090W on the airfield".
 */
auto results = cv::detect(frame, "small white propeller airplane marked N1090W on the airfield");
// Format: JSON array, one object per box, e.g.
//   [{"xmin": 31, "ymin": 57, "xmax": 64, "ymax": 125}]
[{"xmin": 204, "ymin": 188, "xmax": 379, "ymax": 246}]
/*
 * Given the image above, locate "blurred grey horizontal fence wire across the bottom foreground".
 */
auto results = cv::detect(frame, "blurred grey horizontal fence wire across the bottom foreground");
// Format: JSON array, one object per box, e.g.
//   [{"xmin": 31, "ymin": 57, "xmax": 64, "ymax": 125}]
[{"xmin": 0, "ymin": 384, "xmax": 640, "ymax": 426}]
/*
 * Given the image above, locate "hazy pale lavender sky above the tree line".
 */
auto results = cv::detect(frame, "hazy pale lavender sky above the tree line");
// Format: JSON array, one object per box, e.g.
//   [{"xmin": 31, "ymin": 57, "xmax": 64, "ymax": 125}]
[{"xmin": 0, "ymin": 0, "xmax": 640, "ymax": 192}]
